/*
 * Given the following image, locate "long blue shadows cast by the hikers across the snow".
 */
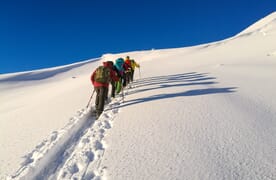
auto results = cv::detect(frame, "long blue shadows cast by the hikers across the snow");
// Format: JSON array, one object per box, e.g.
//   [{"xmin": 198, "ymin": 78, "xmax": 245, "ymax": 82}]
[{"xmin": 114, "ymin": 72, "xmax": 237, "ymax": 107}]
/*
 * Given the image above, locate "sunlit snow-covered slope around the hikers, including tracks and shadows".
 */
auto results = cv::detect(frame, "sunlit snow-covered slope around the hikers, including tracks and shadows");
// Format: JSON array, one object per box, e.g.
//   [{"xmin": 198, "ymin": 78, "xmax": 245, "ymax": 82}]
[{"xmin": 0, "ymin": 13, "xmax": 276, "ymax": 180}]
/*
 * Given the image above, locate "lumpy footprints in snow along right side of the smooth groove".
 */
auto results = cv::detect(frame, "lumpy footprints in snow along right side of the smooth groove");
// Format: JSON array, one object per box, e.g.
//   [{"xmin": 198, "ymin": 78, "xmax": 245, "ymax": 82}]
[{"xmin": 54, "ymin": 98, "xmax": 122, "ymax": 180}]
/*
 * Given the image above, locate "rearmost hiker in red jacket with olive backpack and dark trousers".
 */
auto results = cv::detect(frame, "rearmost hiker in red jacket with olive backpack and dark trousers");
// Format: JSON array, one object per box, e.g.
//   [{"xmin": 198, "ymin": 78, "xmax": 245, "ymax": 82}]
[{"xmin": 91, "ymin": 62, "xmax": 118, "ymax": 119}]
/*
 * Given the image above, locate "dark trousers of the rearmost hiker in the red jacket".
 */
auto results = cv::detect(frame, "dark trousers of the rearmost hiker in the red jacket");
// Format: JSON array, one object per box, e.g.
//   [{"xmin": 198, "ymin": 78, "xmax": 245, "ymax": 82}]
[{"xmin": 95, "ymin": 87, "xmax": 108, "ymax": 119}]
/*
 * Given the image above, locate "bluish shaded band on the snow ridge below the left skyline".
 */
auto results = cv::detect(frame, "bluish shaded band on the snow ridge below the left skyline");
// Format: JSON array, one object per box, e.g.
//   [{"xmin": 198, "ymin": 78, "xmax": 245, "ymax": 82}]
[{"xmin": 0, "ymin": 59, "xmax": 97, "ymax": 82}]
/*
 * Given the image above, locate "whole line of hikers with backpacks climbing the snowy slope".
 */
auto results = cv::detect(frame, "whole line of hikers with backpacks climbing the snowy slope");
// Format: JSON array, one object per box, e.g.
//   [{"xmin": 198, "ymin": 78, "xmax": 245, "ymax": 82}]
[{"xmin": 91, "ymin": 56, "xmax": 140, "ymax": 119}]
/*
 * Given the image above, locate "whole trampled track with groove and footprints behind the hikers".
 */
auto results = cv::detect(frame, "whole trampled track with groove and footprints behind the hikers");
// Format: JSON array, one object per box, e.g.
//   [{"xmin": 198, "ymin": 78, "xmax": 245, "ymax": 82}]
[{"xmin": 7, "ymin": 92, "xmax": 122, "ymax": 180}]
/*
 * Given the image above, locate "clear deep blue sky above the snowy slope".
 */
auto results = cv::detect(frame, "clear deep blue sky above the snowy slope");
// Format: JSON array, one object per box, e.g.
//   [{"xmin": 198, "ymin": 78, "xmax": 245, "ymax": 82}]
[{"xmin": 0, "ymin": 0, "xmax": 276, "ymax": 74}]
